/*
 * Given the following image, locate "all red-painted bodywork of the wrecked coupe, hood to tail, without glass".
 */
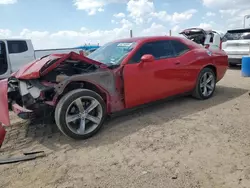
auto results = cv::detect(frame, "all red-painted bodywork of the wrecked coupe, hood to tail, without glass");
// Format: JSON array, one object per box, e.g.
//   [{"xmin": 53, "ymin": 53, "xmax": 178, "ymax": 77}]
[{"xmin": 0, "ymin": 36, "xmax": 228, "ymax": 125}]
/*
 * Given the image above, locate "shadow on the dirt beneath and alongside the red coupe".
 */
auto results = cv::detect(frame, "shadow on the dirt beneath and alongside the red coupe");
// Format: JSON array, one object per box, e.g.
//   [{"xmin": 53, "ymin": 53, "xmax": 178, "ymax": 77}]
[{"xmin": 3, "ymin": 86, "xmax": 248, "ymax": 152}]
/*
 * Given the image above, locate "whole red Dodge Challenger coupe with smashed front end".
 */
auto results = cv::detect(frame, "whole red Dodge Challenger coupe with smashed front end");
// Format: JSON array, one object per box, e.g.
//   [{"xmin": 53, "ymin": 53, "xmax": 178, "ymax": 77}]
[{"xmin": 0, "ymin": 36, "xmax": 228, "ymax": 139}]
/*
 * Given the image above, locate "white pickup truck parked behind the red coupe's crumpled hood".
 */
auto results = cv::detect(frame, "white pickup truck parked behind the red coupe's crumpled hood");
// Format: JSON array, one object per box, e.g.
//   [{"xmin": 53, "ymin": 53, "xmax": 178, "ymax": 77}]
[{"xmin": 0, "ymin": 39, "xmax": 93, "ymax": 79}]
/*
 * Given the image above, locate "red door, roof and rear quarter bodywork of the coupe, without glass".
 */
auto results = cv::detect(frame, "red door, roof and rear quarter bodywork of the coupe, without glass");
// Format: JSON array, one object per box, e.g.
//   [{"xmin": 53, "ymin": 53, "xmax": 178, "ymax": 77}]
[{"xmin": 122, "ymin": 37, "xmax": 228, "ymax": 108}]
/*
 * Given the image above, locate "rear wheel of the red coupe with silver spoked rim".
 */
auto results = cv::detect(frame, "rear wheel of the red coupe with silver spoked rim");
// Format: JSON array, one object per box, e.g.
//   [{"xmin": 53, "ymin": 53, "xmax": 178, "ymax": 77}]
[{"xmin": 193, "ymin": 68, "xmax": 216, "ymax": 100}]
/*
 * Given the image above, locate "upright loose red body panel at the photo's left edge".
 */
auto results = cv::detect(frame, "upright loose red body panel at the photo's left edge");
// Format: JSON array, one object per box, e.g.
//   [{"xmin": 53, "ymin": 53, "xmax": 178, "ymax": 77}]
[{"xmin": 0, "ymin": 79, "xmax": 10, "ymax": 125}]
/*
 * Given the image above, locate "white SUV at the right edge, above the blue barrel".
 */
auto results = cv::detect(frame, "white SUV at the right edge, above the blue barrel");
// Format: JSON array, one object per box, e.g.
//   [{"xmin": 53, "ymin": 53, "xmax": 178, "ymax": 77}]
[{"xmin": 222, "ymin": 28, "xmax": 250, "ymax": 66}]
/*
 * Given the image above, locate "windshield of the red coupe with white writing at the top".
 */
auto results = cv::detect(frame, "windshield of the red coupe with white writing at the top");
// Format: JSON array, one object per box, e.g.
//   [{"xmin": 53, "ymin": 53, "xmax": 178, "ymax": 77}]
[{"xmin": 87, "ymin": 42, "xmax": 136, "ymax": 65}]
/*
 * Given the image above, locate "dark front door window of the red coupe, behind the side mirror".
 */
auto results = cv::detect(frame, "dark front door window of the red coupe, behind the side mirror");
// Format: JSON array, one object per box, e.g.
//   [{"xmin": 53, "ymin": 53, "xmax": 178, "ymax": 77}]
[{"xmin": 129, "ymin": 41, "xmax": 175, "ymax": 64}]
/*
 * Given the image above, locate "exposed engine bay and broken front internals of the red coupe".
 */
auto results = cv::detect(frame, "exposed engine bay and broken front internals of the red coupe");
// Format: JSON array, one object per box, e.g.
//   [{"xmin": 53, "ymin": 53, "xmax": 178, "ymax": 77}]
[{"xmin": 8, "ymin": 59, "xmax": 99, "ymax": 119}]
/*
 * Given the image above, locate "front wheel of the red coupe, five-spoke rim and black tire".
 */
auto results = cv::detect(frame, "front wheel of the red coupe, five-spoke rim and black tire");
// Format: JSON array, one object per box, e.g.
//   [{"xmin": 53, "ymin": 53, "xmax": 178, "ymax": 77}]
[{"xmin": 55, "ymin": 89, "xmax": 107, "ymax": 140}]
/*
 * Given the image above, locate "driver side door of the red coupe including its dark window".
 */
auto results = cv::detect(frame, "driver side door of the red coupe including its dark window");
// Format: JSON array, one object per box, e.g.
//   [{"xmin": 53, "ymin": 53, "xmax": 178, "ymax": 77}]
[{"xmin": 123, "ymin": 41, "xmax": 175, "ymax": 108}]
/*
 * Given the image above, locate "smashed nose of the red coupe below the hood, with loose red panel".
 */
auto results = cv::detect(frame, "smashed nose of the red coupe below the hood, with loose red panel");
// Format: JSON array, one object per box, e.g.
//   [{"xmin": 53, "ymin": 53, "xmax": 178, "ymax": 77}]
[{"xmin": 0, "ymin": 77, "xmax": 52, "ymax": 125}]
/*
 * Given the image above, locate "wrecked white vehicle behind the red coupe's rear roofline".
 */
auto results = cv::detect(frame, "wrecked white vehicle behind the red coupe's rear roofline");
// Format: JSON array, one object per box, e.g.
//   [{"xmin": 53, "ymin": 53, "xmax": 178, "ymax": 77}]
[{"xmin": 180, "ymin": 28, "xmax": 222, "ymax": 49}]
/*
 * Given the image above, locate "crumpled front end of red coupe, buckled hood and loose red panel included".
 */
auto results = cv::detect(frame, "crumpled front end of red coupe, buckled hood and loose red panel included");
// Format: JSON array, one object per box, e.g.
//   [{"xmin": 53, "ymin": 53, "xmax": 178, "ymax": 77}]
[{"xmin": 0, "ymin": 53, "xmax": 110, "ymax": 125}]
